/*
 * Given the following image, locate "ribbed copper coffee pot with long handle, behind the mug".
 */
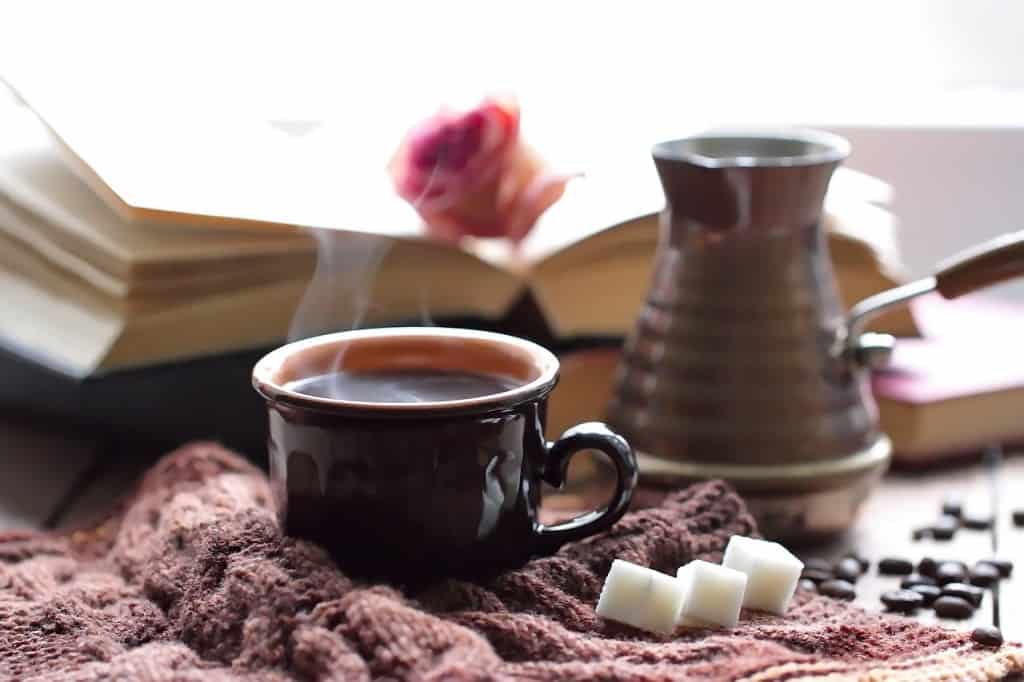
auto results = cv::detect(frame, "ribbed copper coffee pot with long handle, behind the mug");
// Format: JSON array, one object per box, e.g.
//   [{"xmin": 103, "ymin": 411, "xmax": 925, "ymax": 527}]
[{"xmin": 608, "ymin": 130, "xmax": 1024, "ymax": 539}]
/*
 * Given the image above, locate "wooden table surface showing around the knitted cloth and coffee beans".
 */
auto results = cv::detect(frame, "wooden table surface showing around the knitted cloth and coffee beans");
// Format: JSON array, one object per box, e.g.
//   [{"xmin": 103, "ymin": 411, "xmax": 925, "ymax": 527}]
[{"xmin": 0, "ymin": 413, "xmax": 1024, "ymax": 639}]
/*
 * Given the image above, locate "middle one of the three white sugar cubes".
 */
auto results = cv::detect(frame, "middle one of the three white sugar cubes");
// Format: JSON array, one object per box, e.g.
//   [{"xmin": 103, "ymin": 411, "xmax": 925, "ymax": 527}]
[{"xmin": 676, "ymin": 559, "xmax": 746, "ymax": 628}]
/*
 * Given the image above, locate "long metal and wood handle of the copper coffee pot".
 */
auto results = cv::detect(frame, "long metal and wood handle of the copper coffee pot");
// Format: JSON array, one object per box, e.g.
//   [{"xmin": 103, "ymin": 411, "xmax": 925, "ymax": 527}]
[{"xmin": 838, "ymin": 230, "xmax": 1024, "ymax": 368}]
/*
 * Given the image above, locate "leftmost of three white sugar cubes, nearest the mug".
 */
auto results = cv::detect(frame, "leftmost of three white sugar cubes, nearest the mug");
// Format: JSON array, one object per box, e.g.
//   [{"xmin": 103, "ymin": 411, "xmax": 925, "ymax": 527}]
[{"xmin": 597, "ymin": 559, "xmax": 683, "ymax": 635}]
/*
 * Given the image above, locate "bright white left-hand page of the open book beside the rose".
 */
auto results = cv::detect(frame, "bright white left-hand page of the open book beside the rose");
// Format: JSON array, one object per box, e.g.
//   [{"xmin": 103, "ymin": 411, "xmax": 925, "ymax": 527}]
[{"xmin": 1, "ymin": 75, "xmax": 421, "ymax": 237}]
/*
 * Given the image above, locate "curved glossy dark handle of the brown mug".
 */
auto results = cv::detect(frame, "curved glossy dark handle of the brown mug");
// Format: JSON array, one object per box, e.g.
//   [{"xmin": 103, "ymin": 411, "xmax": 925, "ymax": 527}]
[{"xmin": 536, "ymin": 422, "xmax": 637, "ymax": 551}]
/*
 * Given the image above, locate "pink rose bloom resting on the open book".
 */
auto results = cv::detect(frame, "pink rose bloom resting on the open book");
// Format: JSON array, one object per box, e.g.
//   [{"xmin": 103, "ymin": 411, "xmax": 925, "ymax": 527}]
[{"xmin": 389, "ymin": 97, "xmax": 570, "ymax": 244}]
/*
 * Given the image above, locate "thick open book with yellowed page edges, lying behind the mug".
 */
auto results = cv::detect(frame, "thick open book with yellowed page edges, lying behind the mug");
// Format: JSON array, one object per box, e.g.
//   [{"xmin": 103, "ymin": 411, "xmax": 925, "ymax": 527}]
[{"xmin": 0, "ymin": 78, "xmax": 914, "ymax": 377}]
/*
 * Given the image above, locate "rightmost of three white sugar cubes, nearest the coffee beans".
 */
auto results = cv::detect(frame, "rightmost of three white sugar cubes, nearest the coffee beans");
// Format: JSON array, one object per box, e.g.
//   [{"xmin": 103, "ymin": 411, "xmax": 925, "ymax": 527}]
[{"xmin": 722, "ymin": 536, "xmax": 804, "ymax": 615}]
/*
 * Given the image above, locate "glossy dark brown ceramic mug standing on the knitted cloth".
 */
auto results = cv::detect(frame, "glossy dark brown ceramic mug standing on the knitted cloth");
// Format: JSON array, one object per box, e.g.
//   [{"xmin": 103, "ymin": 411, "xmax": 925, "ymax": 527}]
[{"xmin": 253, "ymin": 328, "xmax": 637, "ymax": 581}]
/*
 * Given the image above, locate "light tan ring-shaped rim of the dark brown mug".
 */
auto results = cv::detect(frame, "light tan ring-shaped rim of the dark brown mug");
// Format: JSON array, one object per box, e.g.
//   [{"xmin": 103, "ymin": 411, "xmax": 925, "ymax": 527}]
[{"xmin": 252, "ymin": 327, "xmax": 559, "ymax": 418}]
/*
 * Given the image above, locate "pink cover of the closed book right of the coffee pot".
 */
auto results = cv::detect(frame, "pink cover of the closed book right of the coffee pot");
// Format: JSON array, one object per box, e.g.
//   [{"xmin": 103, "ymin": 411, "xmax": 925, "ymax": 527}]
[{"xmin": 871, "ymin": 296, "xmax": 1024, "ymax": 404}]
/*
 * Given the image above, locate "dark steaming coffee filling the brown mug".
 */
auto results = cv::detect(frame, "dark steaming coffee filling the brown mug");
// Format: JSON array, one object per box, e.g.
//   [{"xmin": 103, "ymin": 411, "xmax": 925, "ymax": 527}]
[{"xmin": 286, "ymin": 370, "xmax": 519, "ymax": 402}]
